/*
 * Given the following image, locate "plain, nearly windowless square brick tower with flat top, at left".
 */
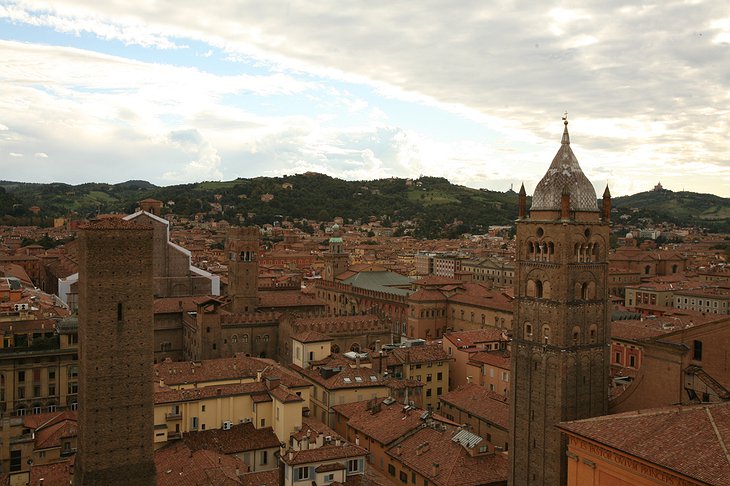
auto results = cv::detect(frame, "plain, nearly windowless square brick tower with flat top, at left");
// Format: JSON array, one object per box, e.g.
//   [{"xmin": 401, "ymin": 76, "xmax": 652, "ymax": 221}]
[{"xmin": 74, "ymin": 219, "xmax": 155, "ymax": 486}]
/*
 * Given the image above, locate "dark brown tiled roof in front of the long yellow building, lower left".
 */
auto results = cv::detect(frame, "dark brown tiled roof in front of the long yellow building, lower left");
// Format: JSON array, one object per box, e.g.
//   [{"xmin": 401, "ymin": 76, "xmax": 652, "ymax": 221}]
[{"xmin": 183, "ymin": 423, "xmax": 280, "ymax": 454}]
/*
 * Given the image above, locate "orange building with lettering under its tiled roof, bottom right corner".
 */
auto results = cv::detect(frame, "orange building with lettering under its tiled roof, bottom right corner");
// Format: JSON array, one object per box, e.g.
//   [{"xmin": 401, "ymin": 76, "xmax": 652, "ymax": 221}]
[{"xmin": 558, "ymin": 403, "xmax": 730, "ymax": 486}]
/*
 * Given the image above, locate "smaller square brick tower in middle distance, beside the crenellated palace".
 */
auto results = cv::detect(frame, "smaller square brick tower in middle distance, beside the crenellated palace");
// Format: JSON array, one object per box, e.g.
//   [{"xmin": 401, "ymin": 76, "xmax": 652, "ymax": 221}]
[{"xmin": 226, "ymin": 226, "xmax": 261, "ymax": 314}]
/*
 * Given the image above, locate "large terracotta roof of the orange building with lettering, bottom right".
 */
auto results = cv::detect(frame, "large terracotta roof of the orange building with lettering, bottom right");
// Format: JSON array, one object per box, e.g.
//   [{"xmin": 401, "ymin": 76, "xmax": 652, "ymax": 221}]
[{"xmin": 558, "ymin": 403, "xmax": 730, "ymax": 484}]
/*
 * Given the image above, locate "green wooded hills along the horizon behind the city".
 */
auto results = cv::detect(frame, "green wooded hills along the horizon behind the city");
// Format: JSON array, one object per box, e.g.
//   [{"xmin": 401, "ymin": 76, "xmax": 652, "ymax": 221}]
[{"xmin": 0, "ymin": 176, "xmax": 730, "ymax": 237}]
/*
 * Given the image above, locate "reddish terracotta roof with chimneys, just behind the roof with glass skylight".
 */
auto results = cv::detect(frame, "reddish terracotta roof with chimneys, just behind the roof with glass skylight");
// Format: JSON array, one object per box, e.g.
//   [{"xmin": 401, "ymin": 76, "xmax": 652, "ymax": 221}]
[{"xmin": 332, "ymin": 398, "xmax": 425, "ymax": 446}]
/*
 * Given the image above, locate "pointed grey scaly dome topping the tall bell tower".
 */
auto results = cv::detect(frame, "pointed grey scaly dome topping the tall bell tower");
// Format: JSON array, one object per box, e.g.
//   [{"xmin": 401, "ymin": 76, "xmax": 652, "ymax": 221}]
[{"xmin": 530, "ymin": 118, "xmax": 598, "ymax": 211}]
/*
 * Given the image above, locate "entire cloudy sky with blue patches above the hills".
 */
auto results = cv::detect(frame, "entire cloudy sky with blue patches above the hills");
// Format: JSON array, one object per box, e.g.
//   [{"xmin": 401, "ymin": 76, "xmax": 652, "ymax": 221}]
[{"xmin": 0, "ymin": 0, "xmax": 730, "ymax": 197}]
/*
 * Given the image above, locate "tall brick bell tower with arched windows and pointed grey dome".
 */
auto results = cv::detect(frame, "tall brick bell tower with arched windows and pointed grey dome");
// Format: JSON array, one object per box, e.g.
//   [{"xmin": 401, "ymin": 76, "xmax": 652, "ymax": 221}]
[{"xmin": 510, "ymin": 118, "xmax": 610, "ymax": 486}]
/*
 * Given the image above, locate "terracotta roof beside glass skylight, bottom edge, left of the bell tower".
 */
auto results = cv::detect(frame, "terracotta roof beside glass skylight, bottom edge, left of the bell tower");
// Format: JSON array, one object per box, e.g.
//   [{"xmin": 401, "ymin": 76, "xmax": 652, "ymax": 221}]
[{"xmin": 388, "ymin": 427, "xmax": 509, "ymax": 486}]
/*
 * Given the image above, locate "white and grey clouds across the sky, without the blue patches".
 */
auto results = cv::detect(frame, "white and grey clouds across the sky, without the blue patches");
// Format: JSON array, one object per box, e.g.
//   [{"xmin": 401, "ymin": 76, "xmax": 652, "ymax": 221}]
[{"xmin": 0, "ymin": 0, "xmax": 730, "ymax": 195}]
